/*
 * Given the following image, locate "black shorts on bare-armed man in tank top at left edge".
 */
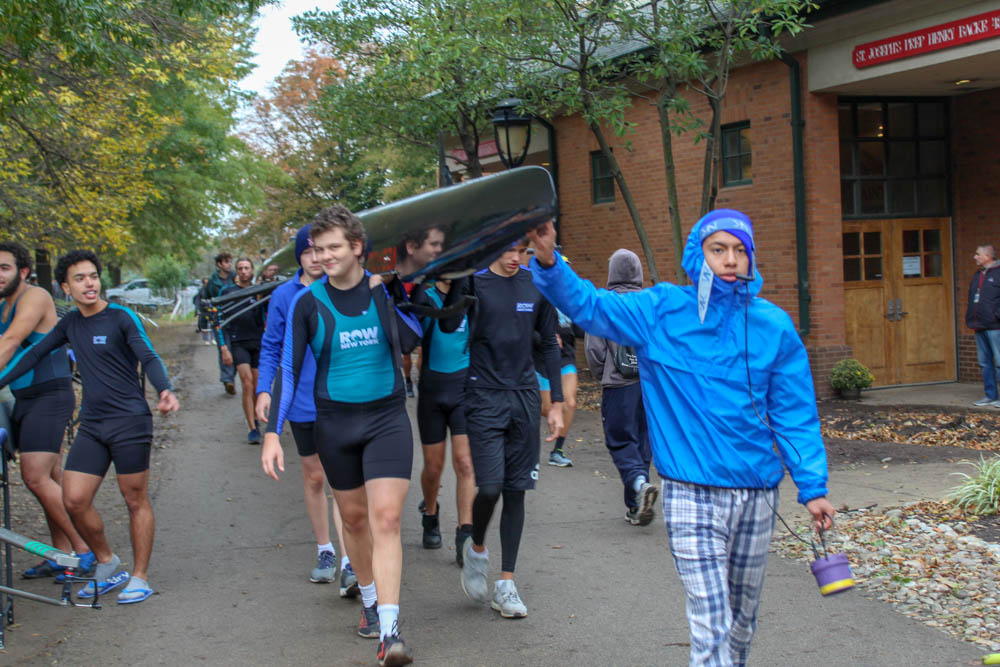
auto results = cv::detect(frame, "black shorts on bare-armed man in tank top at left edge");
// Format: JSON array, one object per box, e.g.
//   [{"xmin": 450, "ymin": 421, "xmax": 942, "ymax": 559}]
[{"xmin": 10, "ymin": 378, "xmax": 76, "ymax": 454}]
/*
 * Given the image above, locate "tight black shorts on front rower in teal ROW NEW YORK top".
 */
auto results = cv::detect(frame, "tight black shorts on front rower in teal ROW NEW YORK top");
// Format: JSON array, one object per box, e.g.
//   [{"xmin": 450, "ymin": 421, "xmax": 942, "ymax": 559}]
[{"xmin": 314, "ymin": 394, "xmax": 413, "ymax": 491}]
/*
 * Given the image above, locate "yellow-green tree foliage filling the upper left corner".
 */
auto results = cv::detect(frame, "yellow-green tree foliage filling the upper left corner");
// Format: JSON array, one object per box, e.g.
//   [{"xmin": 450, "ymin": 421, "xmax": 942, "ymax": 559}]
[{"xmin": 0, "ymin": 0, "xmax": 259, "ymax": 268}]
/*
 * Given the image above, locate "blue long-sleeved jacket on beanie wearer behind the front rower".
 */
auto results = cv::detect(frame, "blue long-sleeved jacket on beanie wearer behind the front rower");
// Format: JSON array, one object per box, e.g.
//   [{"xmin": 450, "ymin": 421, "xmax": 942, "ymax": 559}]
[{"xmin": 257, "ymin": 269, "xmax": 316, "ymax": 432}]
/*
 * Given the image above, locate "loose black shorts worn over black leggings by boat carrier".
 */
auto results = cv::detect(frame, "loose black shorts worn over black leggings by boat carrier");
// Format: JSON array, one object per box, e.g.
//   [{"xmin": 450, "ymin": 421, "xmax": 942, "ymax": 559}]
[{"xmin": 465, "ymin": 388, "xmax": 542, "ymax": 491}]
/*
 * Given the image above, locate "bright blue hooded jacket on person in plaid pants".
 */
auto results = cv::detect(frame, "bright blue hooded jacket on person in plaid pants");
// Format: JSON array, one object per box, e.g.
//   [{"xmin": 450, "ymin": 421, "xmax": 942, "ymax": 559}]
[{"xmin": 532, "ymin": 221, "xmax": 827, "ymax": 503}]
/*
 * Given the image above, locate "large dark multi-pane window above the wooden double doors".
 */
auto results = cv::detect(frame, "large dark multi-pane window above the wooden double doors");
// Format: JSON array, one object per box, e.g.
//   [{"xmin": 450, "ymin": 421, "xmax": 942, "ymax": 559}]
[{"xmin": 838, "ymin": 98, "xmax": 950, "ymax": 218}]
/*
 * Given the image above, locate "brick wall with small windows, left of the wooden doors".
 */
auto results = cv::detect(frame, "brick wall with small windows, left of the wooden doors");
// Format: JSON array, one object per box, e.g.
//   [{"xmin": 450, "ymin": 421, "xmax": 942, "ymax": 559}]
[{"xmin": 555, "ymin": 54, "xmax": 850, "ymax": 396}]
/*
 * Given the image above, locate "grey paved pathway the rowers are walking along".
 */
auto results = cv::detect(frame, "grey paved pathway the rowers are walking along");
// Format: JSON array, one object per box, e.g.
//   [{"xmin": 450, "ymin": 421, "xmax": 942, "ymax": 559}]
[{"xmin": 0, "ymin": 337, "xmax": 980, "ymax": 667}]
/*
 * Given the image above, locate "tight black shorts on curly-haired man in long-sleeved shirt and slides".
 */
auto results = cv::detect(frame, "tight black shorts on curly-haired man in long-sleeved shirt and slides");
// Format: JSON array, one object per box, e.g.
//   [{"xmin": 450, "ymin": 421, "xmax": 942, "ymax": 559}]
[{"xmin": 66, "ymin": 415, "xmax": 153, "ymax": 477}]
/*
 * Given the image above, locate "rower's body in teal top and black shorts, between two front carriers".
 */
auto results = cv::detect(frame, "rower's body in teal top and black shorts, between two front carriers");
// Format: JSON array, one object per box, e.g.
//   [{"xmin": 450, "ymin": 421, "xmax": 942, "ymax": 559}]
[{"xmin": 413, "ymin": 280, "xmax": 476, "ymax": 566}]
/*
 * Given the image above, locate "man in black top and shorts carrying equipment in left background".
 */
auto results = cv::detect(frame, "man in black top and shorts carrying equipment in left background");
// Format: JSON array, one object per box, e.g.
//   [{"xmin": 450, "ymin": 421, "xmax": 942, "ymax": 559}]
[{"xmin": 218, "ymin": 257, "xmax": 264, "ymax": 445}]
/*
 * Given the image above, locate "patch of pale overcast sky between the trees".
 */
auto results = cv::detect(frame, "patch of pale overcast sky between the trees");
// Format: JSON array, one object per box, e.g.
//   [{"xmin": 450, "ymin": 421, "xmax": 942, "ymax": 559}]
[{"xmin": 240, "ymin": 0, "xmax": 337, "ymax": 94}]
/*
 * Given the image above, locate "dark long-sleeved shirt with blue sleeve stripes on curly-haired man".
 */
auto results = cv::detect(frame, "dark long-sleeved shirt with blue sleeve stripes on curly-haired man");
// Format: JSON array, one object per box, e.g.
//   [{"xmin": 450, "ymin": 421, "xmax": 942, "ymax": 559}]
[{"xmin": 0, "ymin": 303, "xmax": 170, "ymax": 420}]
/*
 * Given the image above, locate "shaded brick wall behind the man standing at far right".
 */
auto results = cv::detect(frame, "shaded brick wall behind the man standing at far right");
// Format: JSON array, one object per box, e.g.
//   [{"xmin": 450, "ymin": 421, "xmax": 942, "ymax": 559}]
[{"xmin": 951, "ymin": 89, "xmax": 1000, "ymax": 382}]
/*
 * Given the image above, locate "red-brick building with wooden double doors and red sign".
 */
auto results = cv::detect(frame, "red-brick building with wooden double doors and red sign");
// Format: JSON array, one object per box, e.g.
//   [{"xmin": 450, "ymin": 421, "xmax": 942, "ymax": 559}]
[{"xmin": 452, "ymin": 0, "xmax": 1000, "ymax": 396}]
